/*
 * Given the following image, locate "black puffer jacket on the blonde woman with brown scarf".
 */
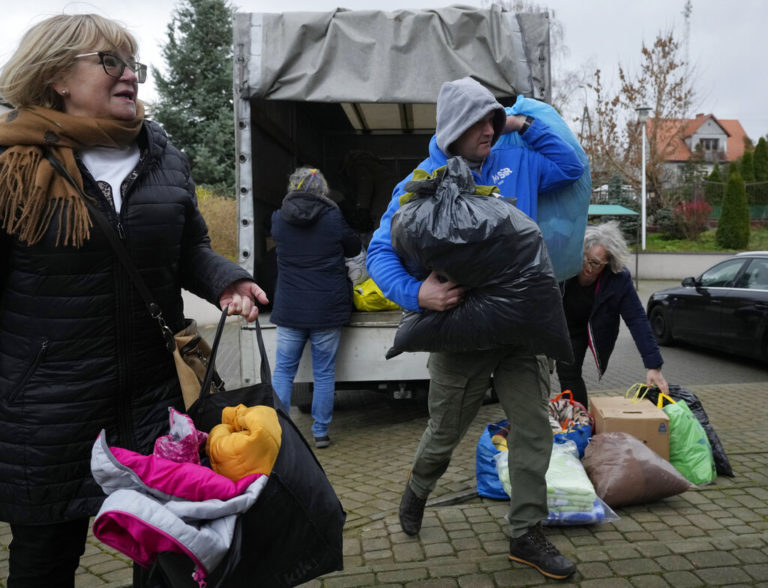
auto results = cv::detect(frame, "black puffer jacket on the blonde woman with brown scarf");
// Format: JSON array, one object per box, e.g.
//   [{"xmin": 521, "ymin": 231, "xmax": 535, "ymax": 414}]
[{"xmin": 0, "ymin": 122, "xmax": 250, "ymax": 524}]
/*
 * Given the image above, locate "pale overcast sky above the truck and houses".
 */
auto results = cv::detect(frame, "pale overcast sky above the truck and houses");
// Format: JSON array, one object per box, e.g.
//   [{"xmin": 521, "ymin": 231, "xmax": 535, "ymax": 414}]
[{"xmin": 0, "ymin": 0, "xmax": 768, "ymax": 141}]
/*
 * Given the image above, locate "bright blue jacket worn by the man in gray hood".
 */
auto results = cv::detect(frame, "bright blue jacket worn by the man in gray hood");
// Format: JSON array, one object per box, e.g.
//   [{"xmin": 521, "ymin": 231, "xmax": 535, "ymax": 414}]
[{"xmin": 367, "ymin": 111, "xmax": 584, "ymax": 311}]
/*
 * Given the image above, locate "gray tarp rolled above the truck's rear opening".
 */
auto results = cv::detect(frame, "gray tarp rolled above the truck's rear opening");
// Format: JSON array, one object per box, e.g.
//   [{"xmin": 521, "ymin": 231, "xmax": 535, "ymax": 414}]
[{"xmin": 235, "ymin": 5, "xmax": 550, "ymax": 103}]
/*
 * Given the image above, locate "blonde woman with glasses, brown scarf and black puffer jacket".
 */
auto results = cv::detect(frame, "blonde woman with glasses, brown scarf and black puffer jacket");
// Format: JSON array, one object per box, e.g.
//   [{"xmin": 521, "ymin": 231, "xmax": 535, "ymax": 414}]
[{"xmin": 0, "ymin": 14, "xmax": 267, "ymax": 588}]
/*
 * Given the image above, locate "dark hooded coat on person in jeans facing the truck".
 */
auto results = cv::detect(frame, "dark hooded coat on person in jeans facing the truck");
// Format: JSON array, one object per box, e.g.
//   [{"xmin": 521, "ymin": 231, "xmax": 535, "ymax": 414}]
[{"xmin": 270, "ymin": 192, "xmax": 361, "ymax": 329}]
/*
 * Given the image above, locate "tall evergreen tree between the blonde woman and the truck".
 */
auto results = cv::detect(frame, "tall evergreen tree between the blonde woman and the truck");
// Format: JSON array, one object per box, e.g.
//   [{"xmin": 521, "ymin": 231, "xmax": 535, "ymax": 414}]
[{"xmin": 152, "ymin": 0, "xmax": 235, "ymax": 189}]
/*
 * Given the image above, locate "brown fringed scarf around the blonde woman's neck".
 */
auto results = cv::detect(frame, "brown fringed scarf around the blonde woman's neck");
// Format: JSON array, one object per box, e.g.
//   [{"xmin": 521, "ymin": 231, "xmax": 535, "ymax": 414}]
[{"xmin": 0, "ymin": 102, "xmax": 144, "ymax": 247}]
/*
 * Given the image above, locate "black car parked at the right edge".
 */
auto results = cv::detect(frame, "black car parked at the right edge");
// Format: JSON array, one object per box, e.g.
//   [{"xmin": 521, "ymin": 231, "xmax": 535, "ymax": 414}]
[{"xmin": 647, "ymin": 251, "xmax": 768, "ymax": 361}]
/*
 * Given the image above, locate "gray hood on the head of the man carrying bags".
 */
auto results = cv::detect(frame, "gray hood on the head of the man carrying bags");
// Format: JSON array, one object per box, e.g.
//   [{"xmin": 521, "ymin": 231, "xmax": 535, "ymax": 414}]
[{"xmin": 435, "ymin": 77, "xmax": 507, "ymax": 156}]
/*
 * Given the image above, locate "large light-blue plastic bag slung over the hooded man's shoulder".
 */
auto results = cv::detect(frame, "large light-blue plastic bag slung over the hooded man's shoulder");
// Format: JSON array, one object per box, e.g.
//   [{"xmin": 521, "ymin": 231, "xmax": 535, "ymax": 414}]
[{"xmin": 499, "ymin": 95, "xmax": 592, "ymax": 282}]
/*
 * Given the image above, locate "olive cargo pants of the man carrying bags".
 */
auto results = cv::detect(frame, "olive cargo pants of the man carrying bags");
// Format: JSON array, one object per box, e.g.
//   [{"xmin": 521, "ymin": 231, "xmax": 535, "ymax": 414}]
[{"xmin": 409, "ymin": 347, "xmax": 552, "ymax": 537}]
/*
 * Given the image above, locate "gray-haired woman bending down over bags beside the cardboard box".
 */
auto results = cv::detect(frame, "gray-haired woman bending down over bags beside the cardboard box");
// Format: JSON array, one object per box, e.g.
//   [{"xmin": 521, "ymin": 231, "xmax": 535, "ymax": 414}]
[{"xmin": 557, "ymin": 221, "xmax": 668, "ymax": 407}]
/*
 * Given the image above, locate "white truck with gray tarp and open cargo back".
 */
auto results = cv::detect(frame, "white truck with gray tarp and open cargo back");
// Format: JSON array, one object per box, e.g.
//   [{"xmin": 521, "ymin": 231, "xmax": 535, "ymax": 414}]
[{"xmin": 234, "ymin": 5, "xmax": 551, "ymax": 409}]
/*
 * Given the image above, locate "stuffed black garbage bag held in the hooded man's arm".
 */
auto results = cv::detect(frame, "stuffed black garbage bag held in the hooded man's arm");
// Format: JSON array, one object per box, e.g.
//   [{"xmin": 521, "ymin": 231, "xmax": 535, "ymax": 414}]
[{"xmin": 387, "ymin": 158, "xmax": 573, "ymax": 361}]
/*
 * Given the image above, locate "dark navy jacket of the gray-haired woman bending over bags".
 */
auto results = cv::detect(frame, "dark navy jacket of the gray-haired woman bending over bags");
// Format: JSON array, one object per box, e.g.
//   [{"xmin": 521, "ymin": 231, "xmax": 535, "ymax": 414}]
[{"xmin": 561, "ymin": 267, "xmax": 664, "ymax": 377}]
